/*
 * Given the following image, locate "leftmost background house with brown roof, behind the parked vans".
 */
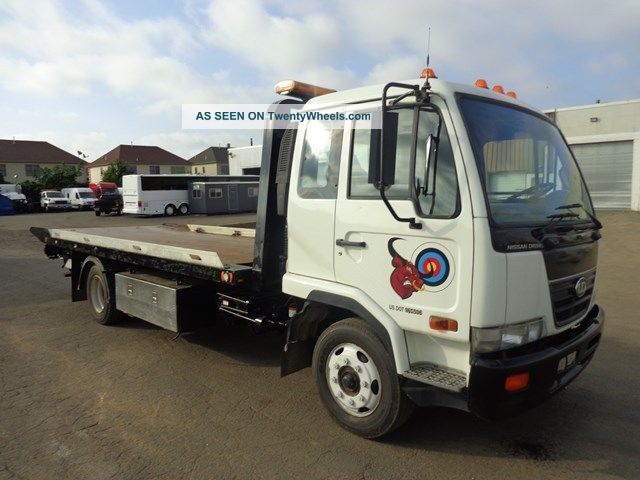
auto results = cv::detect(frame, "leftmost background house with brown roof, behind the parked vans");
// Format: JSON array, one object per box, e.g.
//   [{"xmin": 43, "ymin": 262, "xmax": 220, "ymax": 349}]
[{"xmin": 0, "ymin": 140, "xmax": 88, "ymax": 183}]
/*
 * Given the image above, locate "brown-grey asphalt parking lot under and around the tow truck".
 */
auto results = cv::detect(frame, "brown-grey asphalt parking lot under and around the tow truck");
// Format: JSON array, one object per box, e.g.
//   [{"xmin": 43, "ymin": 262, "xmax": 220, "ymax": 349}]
[{"xmin": 0, "ymin": 212, "xmax": 640, "ymax": 479}]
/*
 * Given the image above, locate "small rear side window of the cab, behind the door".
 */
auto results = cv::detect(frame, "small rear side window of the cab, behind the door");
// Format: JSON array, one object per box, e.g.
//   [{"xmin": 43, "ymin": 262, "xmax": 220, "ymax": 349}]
[{"xmin": 298, "ymin": 121, "xmax": 343, "ymax": 199}]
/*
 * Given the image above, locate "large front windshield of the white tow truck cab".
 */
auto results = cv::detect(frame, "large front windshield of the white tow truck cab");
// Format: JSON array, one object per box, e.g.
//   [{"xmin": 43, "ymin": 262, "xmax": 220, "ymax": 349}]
[{"xmin": 459, "ymin": 96, "xmax": 593, "ymax": 225}]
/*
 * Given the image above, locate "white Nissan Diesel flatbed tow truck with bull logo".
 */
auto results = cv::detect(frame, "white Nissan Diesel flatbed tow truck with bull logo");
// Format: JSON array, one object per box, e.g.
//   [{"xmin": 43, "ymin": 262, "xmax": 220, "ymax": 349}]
[{"xmin": 31, "ymin": 71, "xmax": 604, "ymax": 438}]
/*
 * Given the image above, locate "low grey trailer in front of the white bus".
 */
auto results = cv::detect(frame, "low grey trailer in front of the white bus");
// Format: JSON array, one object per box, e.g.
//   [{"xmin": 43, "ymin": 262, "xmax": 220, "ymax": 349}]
[{"xmin": 189, "ymin": 182, "xmax": 259, "ymax": 215}]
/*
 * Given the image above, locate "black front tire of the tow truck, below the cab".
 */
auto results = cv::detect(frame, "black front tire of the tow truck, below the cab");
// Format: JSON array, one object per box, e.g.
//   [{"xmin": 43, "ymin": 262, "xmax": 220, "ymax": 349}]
[{"xmin": 312, "ymin": 318, "xmax": 414, "ymax": 438}]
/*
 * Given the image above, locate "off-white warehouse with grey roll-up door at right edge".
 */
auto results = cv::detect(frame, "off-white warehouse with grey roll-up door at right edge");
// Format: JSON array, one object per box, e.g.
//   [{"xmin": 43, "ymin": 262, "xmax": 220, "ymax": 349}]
[{"xmin": 545, "ymin": 99, "xmax": 640, "ymax": 210}]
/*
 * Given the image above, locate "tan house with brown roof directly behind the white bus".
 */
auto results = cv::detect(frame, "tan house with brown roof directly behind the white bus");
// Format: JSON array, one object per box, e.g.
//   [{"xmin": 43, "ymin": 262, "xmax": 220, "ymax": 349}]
[{"xmin": 88, "ymin": 145, "xmax": 191, "ymax": 182}]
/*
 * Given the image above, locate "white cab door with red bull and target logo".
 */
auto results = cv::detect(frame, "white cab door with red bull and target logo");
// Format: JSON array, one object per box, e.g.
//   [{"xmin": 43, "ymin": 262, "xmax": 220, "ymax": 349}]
[{"xmin": 334, "ymin": 103, "xmax": 473, "ymax": 370}]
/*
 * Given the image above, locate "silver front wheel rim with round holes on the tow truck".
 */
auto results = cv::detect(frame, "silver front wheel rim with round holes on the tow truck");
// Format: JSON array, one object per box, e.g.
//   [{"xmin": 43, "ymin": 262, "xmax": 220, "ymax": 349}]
[{"xmin": 325, "ymin": 343, "xmax": 382, "ymax": 417}]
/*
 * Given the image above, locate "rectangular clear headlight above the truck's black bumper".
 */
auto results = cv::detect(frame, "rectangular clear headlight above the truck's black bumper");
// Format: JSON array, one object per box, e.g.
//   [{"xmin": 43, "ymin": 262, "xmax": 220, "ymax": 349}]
[{"xmin": 471, "ymin": 318, "xmax": 544, "ymax": 353}]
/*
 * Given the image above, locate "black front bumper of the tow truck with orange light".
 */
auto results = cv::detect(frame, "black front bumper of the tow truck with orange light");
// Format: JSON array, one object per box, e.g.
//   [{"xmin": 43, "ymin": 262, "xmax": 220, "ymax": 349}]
[{"xmin": 468, "ymin": 305, "xmax": 604, "ymax": 418}]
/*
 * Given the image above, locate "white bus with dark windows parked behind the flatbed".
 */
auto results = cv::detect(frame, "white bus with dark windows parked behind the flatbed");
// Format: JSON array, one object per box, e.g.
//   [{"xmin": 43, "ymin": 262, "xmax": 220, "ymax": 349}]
[{"xmin": 122, "ymin": 175, "xmax": 260, "ymax": 216}]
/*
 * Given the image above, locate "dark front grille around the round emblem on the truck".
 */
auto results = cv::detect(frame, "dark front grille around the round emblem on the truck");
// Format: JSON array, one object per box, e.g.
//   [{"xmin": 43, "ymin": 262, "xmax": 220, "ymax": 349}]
[{"xmin": 549, "ymin": 268, "xmax": 596, "ymax": 327}]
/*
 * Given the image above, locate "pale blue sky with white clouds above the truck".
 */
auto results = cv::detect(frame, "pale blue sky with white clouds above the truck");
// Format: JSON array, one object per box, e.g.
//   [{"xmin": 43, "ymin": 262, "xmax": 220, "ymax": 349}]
[{"xmin": 0, "ymin": 0, "xmax": 640, "ymax": 160}]
